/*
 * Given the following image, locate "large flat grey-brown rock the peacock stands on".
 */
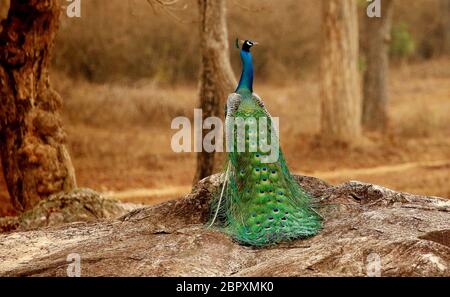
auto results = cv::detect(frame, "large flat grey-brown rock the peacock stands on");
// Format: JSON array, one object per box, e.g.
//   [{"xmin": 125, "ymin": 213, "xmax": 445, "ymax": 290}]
[{"xmin": 0, "ymin": 175, "xmax": 450, "ymax": 276}]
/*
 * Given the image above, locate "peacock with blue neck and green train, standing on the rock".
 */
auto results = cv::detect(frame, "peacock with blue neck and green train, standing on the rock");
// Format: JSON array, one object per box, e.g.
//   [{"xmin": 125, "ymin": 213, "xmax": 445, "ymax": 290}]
[{"xmin": 209, "ymin": 40, "xmax": 322, "ymax": 247}]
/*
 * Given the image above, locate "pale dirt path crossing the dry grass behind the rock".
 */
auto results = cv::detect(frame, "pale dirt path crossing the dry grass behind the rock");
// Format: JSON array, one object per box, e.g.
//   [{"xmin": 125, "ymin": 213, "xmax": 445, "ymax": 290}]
[{"xmin": 104, "ymin": 160, "xmax": 450, "ymax": 204}]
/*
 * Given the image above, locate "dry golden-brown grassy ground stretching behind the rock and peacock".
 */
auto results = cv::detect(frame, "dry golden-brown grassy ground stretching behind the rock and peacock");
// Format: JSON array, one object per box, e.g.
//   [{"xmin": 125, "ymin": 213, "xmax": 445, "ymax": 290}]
[{"xmin": 0, "ymin": 60, "xmax": 450, "ymax": 215}]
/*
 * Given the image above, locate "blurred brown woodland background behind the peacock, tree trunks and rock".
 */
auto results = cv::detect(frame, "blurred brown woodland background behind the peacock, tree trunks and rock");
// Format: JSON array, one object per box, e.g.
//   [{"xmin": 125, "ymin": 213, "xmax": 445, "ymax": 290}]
[{"xmin": 0, "ymin": 0, "xmax": 450, "ymax": 215}]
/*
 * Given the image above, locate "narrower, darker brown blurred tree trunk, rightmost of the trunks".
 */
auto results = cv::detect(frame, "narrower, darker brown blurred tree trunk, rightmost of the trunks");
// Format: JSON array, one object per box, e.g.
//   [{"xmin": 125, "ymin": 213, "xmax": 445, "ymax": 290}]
[{"xmin": 362, "ymin": 0, "xmax": 393, "ymax": 131}]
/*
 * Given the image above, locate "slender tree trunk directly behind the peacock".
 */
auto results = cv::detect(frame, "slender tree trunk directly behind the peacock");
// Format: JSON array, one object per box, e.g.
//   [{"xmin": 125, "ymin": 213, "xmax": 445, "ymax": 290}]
[{"xmin": 194, "ymin": 0, "xmax": 236, "ymax": 183}]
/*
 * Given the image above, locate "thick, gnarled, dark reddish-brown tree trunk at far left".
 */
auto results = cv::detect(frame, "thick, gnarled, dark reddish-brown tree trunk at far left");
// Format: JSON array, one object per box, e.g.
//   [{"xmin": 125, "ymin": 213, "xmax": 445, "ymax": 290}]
[{"xmin": 0, "ymin": 0, "xmax": 75, "ymax": 211}]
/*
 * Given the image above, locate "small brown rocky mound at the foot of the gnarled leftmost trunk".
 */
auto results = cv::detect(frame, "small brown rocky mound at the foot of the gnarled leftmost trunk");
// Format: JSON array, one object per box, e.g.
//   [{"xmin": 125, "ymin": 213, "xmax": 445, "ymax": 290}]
[{"xmin": 0, "ymin": 189, "xmax": 136, "ymax": 232}]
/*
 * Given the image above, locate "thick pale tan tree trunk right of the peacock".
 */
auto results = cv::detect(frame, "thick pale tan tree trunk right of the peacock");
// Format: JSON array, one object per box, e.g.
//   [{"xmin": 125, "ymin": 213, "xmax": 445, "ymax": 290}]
[{"xmin": 321, "ymin": 0, "xmax": 361, "ymax": 143}]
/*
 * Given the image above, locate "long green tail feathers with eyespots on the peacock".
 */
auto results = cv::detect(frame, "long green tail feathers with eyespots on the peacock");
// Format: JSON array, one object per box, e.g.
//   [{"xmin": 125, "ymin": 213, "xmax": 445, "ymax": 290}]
[{"xmin": 210, "ymin": 99, "xmax": 321, "ymax": 246}]
